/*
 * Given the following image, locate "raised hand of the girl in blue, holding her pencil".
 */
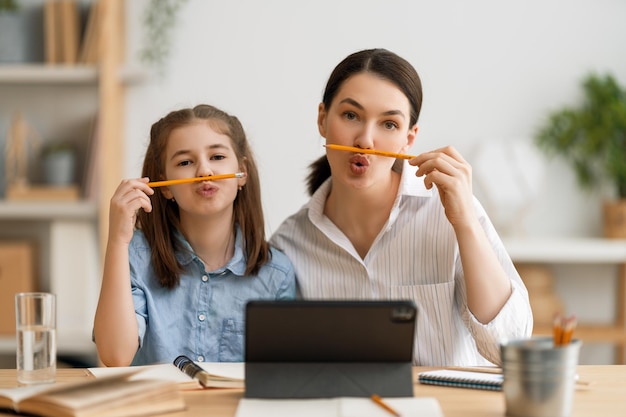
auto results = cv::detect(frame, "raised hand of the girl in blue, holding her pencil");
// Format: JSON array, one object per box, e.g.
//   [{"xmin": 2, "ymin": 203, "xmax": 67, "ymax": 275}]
[{"xmin": 109, "ymin": 178, "xmax": 154, "ymax": 244}]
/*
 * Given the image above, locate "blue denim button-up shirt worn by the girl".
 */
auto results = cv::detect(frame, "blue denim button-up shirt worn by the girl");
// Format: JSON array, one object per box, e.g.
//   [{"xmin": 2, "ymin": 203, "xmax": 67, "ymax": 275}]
[{"xmin": 129, "ymin": 228, "xmax": 296, "ymax": 365}]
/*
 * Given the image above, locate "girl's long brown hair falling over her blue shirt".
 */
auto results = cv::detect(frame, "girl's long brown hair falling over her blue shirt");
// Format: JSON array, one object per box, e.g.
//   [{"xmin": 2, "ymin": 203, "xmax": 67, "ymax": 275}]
[{"xmin": 137, "ymin": 104, "xmax": 271, "ymax": 288}]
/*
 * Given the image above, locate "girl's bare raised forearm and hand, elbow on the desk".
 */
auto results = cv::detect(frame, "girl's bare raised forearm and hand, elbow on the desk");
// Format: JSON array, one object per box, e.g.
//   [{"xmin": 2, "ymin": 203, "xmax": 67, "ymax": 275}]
[{"xmin": 94, "ymin": 178, "xmax": 154, "ymax": 366}]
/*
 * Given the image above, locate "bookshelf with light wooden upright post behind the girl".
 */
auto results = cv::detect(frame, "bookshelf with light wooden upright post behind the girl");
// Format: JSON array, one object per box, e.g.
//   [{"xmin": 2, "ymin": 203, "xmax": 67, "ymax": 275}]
[{"xmin": 0, "ymin": 0, "xmax": 130, "ymax": 356}]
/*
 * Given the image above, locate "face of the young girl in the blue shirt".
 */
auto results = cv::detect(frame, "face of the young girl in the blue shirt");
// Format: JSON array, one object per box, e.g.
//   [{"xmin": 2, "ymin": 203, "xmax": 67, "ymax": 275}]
[{"xmin": 163, "ymin": 120, "xmax": 246, "ymax": 220}]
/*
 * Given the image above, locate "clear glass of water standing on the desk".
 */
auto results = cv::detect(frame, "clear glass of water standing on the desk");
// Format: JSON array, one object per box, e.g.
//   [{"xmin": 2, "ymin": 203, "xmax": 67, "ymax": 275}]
[{"xmin": 15, "ymin": 292, "xmax": 57, "ymax": 385}]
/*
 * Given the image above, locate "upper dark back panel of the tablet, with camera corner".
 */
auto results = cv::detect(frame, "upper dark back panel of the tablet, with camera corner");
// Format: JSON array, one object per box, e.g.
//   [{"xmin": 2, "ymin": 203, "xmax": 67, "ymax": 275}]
[{"xmin": 245, "ymin": 300, "xmax": 417, "ymax": 362}]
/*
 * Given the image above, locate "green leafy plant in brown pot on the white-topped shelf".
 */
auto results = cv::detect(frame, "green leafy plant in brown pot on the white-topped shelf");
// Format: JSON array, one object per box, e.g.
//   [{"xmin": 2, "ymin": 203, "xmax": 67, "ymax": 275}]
[{"xmin": 535, "ymin": 73, "xmax": 626, "ymax": 238}]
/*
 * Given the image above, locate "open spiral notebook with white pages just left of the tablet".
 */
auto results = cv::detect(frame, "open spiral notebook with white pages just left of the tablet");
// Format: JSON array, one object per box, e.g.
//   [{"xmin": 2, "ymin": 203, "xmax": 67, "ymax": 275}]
[{"xmin": 89, "ymin": 362, "xmax": 245, "ymax": 389}]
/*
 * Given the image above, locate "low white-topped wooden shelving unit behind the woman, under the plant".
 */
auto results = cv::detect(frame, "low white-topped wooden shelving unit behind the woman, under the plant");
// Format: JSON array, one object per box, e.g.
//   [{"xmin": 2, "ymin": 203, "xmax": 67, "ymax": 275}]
[{"xmin": 504, "ymin": 238, "xmax": 626, "ymax": 364}]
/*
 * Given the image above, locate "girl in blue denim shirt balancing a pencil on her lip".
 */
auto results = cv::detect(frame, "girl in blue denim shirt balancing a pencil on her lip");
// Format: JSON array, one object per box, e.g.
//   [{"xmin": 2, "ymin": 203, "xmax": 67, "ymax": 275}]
[{"xmin": 94, "ymin": 105, "xmax": 295, "ymax": 366}]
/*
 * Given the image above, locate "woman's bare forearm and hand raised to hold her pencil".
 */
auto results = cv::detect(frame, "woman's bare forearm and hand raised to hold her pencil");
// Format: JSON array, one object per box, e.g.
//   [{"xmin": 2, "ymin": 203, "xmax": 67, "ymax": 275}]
[{"xmin": 410, "ymin": 146, "xmax": 512, "ymax": 324}]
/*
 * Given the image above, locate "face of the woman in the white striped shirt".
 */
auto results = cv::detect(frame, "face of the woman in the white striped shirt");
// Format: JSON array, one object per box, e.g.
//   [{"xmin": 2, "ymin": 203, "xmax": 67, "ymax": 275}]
[{"xmin": 318, "ymin": 72, "xmax": 417, "ymax": 187}]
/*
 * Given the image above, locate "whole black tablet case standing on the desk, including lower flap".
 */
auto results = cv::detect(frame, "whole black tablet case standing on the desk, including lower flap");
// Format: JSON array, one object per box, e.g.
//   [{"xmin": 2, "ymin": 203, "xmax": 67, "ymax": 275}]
[{"xmin": 245, "ymin": 300, "xmax": 417, "ymax": 398}]
